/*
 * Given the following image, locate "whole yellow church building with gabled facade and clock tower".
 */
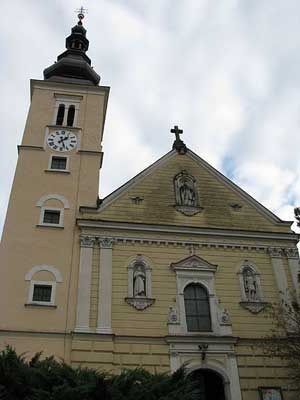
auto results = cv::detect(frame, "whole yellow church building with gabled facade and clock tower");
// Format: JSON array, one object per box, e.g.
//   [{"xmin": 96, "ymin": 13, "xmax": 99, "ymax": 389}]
[{"xmin": 0, "ymin": 14, "xmax": 299, "ymax": 400}]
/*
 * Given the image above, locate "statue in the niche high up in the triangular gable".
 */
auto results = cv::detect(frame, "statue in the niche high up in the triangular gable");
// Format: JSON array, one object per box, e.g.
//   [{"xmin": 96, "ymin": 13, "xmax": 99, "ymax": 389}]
[{"xmin": 174, "ymin": 171, "xmax": 202, "ymax": 215}]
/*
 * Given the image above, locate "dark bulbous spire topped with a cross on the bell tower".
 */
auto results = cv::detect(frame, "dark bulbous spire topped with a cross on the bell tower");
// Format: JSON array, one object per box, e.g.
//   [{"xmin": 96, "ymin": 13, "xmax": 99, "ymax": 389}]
[{"xmin": 44, "ymin": 11, "xmax": 100, "ymax": 86}]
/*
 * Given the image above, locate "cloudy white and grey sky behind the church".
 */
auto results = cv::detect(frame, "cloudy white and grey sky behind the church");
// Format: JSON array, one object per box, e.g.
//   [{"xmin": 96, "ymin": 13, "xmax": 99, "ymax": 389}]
[{"xmin": 0, "ymin": 0, "xmax": 300, "ymax": 232}]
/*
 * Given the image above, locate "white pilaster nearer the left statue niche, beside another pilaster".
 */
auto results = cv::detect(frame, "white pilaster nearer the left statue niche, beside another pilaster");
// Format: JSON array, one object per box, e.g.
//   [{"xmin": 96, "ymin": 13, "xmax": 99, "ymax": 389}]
[{"xmin": 96, "ymin": 238, "xmax": 113, "ymax": 333}]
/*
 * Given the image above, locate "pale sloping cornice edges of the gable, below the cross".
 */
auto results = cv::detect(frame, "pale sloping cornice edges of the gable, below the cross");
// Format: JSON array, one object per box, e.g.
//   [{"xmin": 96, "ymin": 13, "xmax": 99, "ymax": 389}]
[{"xmin": 81, "ymin": 149, "xmax": 293, "ymax": 226}]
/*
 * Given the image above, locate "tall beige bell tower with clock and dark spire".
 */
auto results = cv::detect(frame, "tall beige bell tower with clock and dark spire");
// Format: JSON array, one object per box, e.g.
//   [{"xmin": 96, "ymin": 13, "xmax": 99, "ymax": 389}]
[{"xmin": 0, "ymin": 12, "xmax": 109, "ymax": 346}]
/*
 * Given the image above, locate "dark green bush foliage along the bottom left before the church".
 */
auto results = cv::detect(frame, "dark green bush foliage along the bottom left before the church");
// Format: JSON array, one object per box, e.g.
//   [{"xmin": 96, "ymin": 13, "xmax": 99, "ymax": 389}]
[{"xmin": 0, "ymin": 346, "xmax": 198, "ymax": 400}]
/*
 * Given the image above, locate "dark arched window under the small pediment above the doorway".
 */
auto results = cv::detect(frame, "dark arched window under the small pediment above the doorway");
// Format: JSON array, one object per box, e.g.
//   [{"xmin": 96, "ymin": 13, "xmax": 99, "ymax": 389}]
[{"xmin": 184, "ymin": 283, "xmax": 211, "ymax": 332}]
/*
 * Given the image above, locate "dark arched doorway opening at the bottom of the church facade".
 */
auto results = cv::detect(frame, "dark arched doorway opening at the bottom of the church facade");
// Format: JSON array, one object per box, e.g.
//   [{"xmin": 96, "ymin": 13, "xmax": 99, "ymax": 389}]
[{"xmin": 189, "ymin": 368, "xmax": 227, "ymax": 400}]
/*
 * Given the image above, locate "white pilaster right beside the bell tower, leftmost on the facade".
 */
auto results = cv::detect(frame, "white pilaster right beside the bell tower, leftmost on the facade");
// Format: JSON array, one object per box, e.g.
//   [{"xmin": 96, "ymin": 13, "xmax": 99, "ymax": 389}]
[{"xmin": 75, "ymin": 235, "xmax": 95, "ymax": 332}]
